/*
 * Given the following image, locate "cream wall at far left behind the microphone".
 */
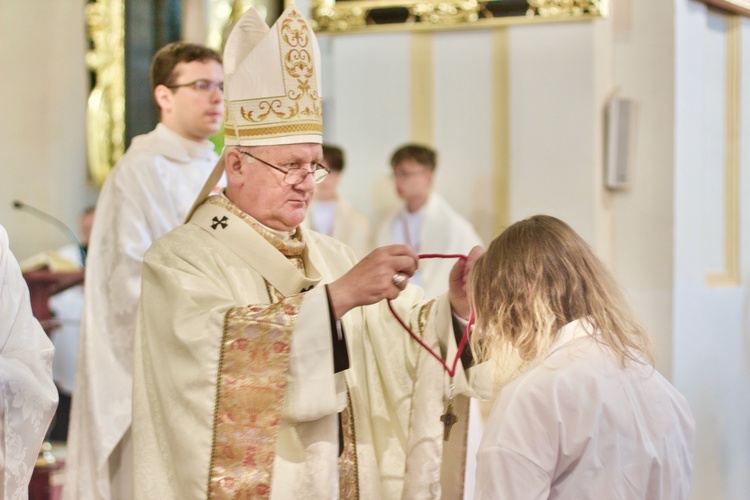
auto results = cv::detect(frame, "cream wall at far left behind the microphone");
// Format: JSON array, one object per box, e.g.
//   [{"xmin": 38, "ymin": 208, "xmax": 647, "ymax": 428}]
[{"xmin": 0, "ymin": 0, "xmax": 95, "ymax": 260}]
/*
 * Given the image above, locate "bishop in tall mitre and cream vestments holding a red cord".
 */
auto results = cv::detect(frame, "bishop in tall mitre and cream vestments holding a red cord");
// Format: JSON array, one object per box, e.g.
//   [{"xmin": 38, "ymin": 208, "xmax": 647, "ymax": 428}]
[{"xmin": 132, "ymin": 6, "xmax": 490, "ymax": 500}]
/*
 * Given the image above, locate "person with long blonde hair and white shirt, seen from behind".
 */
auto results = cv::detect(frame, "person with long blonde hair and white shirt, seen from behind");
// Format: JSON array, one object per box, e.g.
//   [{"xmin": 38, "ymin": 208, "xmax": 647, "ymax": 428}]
[{"xmin": 470, "ymin": 215, "xmax": 695, "ymax": 500}]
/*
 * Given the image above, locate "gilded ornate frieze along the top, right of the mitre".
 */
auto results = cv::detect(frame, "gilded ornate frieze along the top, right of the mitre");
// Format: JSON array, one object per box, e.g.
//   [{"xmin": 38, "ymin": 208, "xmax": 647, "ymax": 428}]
[{"xmin": 311, "ymin": 0, "xmax": 608, "ymax": 33}]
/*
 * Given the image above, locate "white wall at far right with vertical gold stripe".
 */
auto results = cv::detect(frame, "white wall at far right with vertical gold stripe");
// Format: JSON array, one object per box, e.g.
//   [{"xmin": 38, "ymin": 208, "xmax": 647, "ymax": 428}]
[{"xmin": 674, "ymin": 2, "xmax": 750, "ymax": 500}]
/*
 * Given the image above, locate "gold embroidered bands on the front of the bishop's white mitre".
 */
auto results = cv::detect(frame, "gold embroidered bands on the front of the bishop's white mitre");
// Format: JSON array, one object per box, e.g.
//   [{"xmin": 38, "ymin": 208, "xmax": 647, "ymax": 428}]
[{"xmin": 224, "ymin": 10, "xmax": 323, "ymax": 143}]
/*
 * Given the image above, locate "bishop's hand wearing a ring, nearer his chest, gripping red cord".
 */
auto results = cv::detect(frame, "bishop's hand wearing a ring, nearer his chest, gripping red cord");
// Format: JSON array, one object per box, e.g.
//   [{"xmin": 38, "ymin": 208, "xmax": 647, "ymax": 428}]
[{"xmin": 328, "ymin": 245, "xmax": 419, "ymax": 319}]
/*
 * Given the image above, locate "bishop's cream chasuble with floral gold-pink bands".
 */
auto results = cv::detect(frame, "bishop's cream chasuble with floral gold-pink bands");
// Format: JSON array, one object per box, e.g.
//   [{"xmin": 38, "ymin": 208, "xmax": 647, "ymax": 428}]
[{"xmin": 133, "ymin": 197, "xmax": 488, "ymax": 500}]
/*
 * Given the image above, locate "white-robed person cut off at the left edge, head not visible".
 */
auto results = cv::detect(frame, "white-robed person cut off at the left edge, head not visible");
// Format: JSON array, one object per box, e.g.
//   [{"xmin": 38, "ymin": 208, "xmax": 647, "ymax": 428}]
[{"xmin": 0, "ymin": 226, "xmax": 57, "ymax": 499}]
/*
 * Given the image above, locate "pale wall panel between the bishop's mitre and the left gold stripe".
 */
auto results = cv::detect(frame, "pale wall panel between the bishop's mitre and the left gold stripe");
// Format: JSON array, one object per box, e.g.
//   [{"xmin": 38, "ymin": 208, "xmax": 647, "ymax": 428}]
[{"xmin": 319, "ymin": 33, "xmax": 411, "ymax": 231}]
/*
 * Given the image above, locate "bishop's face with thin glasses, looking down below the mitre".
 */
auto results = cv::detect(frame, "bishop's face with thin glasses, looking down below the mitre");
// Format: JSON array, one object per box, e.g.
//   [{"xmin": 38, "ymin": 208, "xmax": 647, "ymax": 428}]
[{"xmin": 225, "ymin": 143, "xmax": 323, "ymax": 231}]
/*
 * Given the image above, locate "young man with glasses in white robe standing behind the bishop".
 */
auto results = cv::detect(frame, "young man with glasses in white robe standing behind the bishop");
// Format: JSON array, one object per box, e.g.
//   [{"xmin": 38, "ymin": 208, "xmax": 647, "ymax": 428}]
[{"xmin": 63, "ymin": 42, "xmax": 224, "ymax": 500}]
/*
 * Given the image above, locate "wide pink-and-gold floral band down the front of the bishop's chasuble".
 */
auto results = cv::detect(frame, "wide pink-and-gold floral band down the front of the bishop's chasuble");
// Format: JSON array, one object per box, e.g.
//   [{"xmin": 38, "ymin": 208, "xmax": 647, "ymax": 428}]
[{"xmin": 208, "ymin": 295, "xmax": 302, "ymax": 499}]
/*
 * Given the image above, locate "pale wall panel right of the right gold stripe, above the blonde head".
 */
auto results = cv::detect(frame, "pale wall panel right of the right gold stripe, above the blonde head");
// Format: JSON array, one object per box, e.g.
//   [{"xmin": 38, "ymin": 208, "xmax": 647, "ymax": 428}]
[{"xmin": 509, "ymin": 22, "xmax": 601, "ymax": 242}]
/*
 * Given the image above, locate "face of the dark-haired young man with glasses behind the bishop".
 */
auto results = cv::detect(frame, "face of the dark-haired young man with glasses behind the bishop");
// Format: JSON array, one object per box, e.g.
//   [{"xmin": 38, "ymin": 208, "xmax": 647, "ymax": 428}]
[{"xmin": 154, "ymin": 59, "xmax": 224, "ymax": 142}]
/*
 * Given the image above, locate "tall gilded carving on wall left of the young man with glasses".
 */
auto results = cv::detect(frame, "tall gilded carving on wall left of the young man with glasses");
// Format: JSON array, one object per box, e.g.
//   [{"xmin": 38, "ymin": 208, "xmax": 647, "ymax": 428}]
[{"xmin": 86, "ymin": 0, "xmax": 125, "ymax": 186}]
